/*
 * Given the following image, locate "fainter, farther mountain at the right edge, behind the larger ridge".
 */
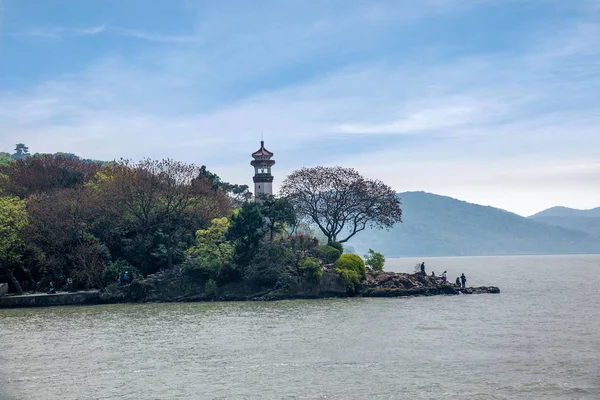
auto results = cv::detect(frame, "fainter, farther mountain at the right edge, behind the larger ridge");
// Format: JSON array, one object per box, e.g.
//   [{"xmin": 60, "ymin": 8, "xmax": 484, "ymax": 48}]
[{"xmin": 529, "ymin": 207, "xmax": 600, "ymax": 238}]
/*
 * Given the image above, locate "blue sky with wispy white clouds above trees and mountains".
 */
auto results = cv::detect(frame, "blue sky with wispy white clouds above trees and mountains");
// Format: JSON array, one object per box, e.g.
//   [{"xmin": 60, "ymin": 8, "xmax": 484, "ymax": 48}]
[{"xmin": 0, "ymin": 0, "xmax": 600, "ymax": 216}]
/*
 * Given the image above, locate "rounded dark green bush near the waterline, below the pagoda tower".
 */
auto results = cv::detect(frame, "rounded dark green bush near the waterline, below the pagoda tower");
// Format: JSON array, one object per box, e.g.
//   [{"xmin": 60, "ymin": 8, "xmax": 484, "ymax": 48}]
[{"xmin": 244, "ymin": 243, "xmax": 294, "ymax": 286}]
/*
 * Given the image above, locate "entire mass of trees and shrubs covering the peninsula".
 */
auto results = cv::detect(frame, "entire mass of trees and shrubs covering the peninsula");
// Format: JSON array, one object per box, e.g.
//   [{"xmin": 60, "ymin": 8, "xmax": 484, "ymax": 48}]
[{"xmin": 0, "ymin": 144, "xmax": 496, "ymax": 305}]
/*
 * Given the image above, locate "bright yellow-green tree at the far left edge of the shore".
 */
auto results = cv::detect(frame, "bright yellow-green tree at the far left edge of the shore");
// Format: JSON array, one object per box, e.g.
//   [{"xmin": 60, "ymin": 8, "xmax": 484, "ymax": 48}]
[{"xmin": 0, "ymin": 196, "xmax": 28, "ymax": 294}]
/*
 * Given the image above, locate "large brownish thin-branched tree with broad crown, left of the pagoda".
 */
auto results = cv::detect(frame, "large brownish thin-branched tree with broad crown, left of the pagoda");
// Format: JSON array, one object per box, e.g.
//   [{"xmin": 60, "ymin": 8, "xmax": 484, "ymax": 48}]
[{"xmin": 91, "ymin": 159, "xmax": 229, "ymax": 273}]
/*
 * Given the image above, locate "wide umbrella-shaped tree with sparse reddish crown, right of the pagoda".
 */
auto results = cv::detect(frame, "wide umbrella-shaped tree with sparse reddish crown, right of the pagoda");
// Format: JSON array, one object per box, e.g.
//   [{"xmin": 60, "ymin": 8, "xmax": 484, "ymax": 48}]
[{"xmin": 281, "ymin": 167, "xmax": 402, "ymax": 244}]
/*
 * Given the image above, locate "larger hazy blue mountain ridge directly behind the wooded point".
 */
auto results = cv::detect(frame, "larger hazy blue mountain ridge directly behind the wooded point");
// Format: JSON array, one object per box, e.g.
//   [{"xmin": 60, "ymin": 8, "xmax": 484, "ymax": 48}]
[{"xmin": 349, "ymin": 192, "xmax": 600, "ymax": 257}]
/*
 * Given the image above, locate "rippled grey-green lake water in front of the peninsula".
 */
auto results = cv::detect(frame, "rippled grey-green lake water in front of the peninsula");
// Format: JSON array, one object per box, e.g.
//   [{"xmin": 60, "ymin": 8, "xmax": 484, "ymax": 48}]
[{"xmin": 0, "ymin": 256, "xmax": 600, "ymax": 400}]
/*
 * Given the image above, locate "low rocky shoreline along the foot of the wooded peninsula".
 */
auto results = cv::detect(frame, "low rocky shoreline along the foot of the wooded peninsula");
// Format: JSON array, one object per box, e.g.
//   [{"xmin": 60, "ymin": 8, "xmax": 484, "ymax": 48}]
[{"xmin": 0, "ymin": 268, "xmax": 500, "ymax": 308}]
